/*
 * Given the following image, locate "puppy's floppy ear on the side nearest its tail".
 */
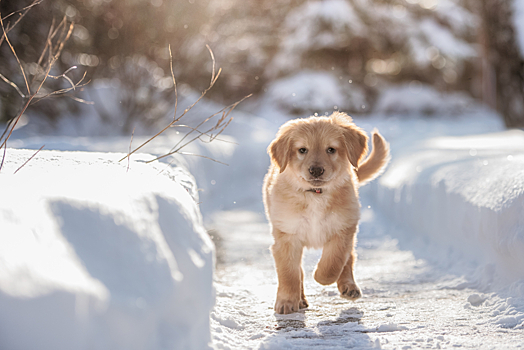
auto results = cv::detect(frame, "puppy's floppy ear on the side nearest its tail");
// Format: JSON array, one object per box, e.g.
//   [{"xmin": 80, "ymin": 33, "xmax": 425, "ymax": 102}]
[{"xmin": 332, "ymin": 113, "xmax": 368, "ymax": 168}]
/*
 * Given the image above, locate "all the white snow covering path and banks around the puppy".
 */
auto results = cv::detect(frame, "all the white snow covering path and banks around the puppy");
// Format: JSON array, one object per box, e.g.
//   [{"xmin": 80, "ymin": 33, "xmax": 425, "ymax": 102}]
[{"xmin": 0, "ymin": 83, "xmax": 524, "ymax": 350}]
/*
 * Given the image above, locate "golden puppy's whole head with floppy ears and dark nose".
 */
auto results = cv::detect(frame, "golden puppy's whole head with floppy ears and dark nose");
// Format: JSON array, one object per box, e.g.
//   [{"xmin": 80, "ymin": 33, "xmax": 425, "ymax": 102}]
[{"xmin": 268, "ymin": 112, "xmax": 368, "ymax": 187}]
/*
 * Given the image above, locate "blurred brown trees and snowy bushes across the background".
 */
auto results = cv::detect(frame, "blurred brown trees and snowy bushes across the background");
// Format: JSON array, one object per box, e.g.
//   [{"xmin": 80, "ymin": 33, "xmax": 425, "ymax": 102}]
[{"xmin": 0, "ymin": 0, "xmax": 524, "ymax": 133}]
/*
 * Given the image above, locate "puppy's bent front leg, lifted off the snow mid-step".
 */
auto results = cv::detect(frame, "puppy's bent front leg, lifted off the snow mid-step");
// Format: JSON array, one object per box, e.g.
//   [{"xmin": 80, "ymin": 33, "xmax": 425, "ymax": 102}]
[{"xmin": 313, "ymin": 225, "xmax": 357, "ymax": 286}]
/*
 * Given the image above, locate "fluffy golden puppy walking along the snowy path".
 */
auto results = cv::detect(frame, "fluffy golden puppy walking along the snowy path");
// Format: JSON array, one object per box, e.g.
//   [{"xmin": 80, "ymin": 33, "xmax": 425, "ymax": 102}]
[{"xmin": 263, "ymin": 112, "xmax": 389, "ymax": 314}]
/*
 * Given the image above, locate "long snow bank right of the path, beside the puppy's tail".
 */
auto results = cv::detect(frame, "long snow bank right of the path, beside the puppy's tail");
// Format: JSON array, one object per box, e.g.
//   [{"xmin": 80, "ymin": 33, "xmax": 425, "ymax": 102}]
[{"xmin": 371, "ymin": 118, "xmax": 524, "ymax": 340}]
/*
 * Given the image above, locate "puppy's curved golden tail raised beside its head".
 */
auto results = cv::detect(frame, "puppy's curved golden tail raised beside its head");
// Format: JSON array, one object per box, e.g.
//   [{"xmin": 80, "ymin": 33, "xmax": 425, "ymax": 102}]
[{"xmin": 356, "ymin": 129, "xmax": 390, "ymax": 185}]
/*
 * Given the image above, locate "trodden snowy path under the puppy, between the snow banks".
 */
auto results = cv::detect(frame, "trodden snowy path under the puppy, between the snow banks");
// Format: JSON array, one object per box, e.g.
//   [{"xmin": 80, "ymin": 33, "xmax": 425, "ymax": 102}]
[{"xmin": 211, "ymin": 198, "xmax": 524, "ymax": 349}]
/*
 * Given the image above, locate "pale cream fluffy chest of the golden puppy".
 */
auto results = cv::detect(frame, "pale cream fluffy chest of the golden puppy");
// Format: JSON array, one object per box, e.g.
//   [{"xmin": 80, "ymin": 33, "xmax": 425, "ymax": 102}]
[{"xmin": 273, "ymin": 194, "xmax": 358, "ymax": 248}]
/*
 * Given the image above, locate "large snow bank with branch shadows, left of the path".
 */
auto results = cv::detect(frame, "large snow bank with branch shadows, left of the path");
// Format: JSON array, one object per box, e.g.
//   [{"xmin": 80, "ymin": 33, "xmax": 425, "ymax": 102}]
[{"xmin": 0, "ymin": 149, "xmax": 214, "ymax": 350}]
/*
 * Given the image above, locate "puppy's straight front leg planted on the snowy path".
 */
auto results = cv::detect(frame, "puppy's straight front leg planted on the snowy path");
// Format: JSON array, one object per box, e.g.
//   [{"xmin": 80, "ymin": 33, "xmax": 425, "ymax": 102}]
[{"xmin": 271, "ymin": 229, "xmax": 307, "ymax": 314}]
